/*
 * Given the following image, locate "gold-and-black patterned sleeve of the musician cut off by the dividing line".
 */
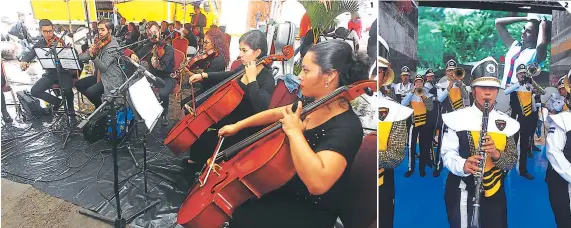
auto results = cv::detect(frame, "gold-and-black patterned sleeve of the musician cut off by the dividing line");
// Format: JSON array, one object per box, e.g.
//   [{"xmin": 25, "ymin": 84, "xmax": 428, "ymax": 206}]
[{"xmin": 378, "ymin": 120, "xmax": 408, "ymax": 169}]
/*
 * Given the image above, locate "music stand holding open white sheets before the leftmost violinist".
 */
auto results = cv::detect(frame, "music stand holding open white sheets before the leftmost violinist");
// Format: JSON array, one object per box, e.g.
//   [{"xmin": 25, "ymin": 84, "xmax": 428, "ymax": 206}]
[{"xmin": 34, "ymin": 45, "xmax": 81, "ymax": 149}]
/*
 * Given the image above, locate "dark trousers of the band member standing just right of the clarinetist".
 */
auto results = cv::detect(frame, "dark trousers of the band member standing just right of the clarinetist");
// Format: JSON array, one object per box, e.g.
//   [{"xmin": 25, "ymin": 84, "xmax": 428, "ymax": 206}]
[{"xmin": 512, "ymin": 112, "xmax": 538, "ymax": 173}]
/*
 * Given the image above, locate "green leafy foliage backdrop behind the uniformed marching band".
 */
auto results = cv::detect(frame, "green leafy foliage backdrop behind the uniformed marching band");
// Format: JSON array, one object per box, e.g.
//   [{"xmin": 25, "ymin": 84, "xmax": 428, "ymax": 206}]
[{"xmin": 418, "ymin": 7, "xmax": 551, "ymax": 72}]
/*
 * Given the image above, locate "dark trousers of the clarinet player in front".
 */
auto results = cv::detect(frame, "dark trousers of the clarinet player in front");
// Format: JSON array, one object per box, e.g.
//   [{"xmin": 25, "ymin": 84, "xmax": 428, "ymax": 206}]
[{"xmin": 444, "ymin": 178, "xmax": 508, "ymax": 228}]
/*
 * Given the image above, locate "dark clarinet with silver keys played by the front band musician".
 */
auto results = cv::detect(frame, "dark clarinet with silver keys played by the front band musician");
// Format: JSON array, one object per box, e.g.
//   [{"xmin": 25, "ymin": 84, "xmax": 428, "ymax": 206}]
[{"xmin": 470, "ymin": 100, "xmax": 490, "ymax": 228}]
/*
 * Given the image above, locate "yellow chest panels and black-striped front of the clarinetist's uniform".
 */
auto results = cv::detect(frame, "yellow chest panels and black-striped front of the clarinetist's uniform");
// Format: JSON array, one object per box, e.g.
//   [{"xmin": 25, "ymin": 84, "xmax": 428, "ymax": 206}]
[{"xmin": 470, "ymin": 131, "xmax": 507, "ymax": 197}]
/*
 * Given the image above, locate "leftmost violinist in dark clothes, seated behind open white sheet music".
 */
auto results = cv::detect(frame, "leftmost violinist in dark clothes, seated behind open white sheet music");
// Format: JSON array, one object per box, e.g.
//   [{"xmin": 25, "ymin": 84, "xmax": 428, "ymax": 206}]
[{"xmin": 20, "ymin": 19, "xmax": 77, "ymax": 115}]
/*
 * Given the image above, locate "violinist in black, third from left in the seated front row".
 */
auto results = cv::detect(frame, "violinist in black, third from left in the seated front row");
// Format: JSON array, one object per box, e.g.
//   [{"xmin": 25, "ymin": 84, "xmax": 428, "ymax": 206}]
[{"xmin": 131, "ymin": 22, "xmax": 176, "ymax": 126}]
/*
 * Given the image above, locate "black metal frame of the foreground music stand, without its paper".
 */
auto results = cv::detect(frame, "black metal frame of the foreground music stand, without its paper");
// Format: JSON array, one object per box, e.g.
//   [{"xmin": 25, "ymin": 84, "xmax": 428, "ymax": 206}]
[{"xmin": 78, "ymin": 67, "xmax": 159, "ymax": 228}]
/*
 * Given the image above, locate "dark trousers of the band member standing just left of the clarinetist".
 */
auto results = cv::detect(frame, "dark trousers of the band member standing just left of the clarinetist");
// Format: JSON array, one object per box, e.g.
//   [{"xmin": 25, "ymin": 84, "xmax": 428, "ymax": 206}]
[{"xmin": 409, "ymin": 124, "xmax": 433, "ymax": 172}]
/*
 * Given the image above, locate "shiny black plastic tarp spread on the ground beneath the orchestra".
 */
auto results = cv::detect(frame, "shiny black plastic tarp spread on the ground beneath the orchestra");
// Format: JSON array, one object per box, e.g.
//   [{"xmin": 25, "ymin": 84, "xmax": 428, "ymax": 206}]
[{"xmin": 1, "ymin": 117, "xmax": 194, "ymax": 227}]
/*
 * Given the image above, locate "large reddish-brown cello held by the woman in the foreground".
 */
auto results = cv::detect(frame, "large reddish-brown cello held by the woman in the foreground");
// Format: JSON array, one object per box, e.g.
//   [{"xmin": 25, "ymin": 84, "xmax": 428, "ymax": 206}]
[{"xmin": 177, "ymin": 80, "xmax": 377, "ymax": 228}]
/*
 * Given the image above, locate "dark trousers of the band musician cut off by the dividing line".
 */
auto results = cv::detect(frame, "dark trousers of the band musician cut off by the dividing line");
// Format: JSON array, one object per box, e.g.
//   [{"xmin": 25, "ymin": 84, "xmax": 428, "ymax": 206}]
[{"xmin": 377, "ymin": 169, "xmax": 395, "ymax": 228}]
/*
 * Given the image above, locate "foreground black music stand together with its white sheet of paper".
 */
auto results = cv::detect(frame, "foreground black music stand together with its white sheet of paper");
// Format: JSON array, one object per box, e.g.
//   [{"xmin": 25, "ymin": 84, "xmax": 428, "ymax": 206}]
[{"xmin": 78, "ymin": 67, "xmax": 162, "ymax": 228}]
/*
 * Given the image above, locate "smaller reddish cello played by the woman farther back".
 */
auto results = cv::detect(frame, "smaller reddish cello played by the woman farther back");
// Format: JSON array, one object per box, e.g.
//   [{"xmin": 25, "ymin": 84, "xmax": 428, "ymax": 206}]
[{"xmin": 164, "ymin": 46, "xmax": 293, "ymax": 155}]
